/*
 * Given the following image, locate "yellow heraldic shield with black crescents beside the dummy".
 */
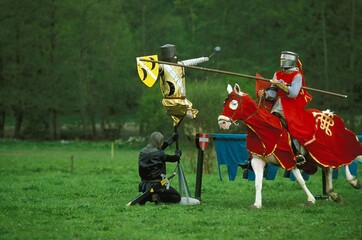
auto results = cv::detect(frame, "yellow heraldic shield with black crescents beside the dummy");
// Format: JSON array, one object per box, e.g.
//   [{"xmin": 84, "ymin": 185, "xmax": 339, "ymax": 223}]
[{"xmin": 136, "ymin": 55, "xmax": 159, "ymax": 87}]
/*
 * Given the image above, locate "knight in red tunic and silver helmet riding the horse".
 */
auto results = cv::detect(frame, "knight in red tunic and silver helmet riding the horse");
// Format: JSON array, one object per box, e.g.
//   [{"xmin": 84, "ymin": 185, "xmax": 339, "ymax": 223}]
[{"xmin": 258, "ymin": 51, "xmax": 317, "ymax": 164}]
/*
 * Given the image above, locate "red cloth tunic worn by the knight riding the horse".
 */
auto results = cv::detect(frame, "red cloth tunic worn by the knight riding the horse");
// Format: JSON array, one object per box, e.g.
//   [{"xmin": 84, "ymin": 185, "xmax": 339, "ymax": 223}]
[{"xmin": 276, "ymin": 71, "xmax": 317, "ymax": 146}]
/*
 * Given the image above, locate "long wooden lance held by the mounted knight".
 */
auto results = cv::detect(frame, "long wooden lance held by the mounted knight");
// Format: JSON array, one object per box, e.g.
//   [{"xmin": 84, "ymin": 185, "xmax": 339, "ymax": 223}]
[{"xmin": 139, "ymin": 58, "xmax": 347, "ymax": 98}]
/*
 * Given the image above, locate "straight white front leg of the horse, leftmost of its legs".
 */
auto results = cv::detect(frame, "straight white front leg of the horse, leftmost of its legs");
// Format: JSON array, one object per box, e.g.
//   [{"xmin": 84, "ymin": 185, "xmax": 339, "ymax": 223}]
[{"xmin": 250, "ymin": 155, "xmax": 266, "ymax": 208}]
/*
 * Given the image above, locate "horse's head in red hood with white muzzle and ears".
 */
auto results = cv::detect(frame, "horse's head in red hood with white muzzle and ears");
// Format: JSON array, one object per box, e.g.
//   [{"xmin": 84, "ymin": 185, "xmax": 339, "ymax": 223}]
[{"xmin": 218, "ymin": 84, "xmax": 258, "ymax": 129}]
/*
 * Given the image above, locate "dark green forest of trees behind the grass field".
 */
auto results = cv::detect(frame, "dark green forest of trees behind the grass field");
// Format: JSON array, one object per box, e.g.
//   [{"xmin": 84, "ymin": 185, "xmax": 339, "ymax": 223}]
[{"xmin": 0, "ymin": 0, "xmax": 362, "ymax": 140}]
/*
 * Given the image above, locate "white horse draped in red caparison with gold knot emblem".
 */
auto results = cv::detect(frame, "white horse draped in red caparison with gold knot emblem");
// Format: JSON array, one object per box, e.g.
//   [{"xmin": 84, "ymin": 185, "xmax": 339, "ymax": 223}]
[{"xmin": 218, "ymin": 84, "xmax": 362, "ymax": 208}]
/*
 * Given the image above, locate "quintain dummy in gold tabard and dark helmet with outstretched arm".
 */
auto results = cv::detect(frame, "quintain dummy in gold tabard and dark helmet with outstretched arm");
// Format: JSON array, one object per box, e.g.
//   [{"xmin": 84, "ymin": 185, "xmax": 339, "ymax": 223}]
[{"xmin": 160, "ymin": 44, "xmax": 209, "ymax": 126}]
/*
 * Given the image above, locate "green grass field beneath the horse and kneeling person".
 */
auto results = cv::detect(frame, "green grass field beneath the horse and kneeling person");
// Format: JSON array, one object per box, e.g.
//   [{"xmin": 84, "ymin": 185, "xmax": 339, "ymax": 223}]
[{"xmin": 0, "ymin": 141, "xmax": 362, "ymax": 239}]
